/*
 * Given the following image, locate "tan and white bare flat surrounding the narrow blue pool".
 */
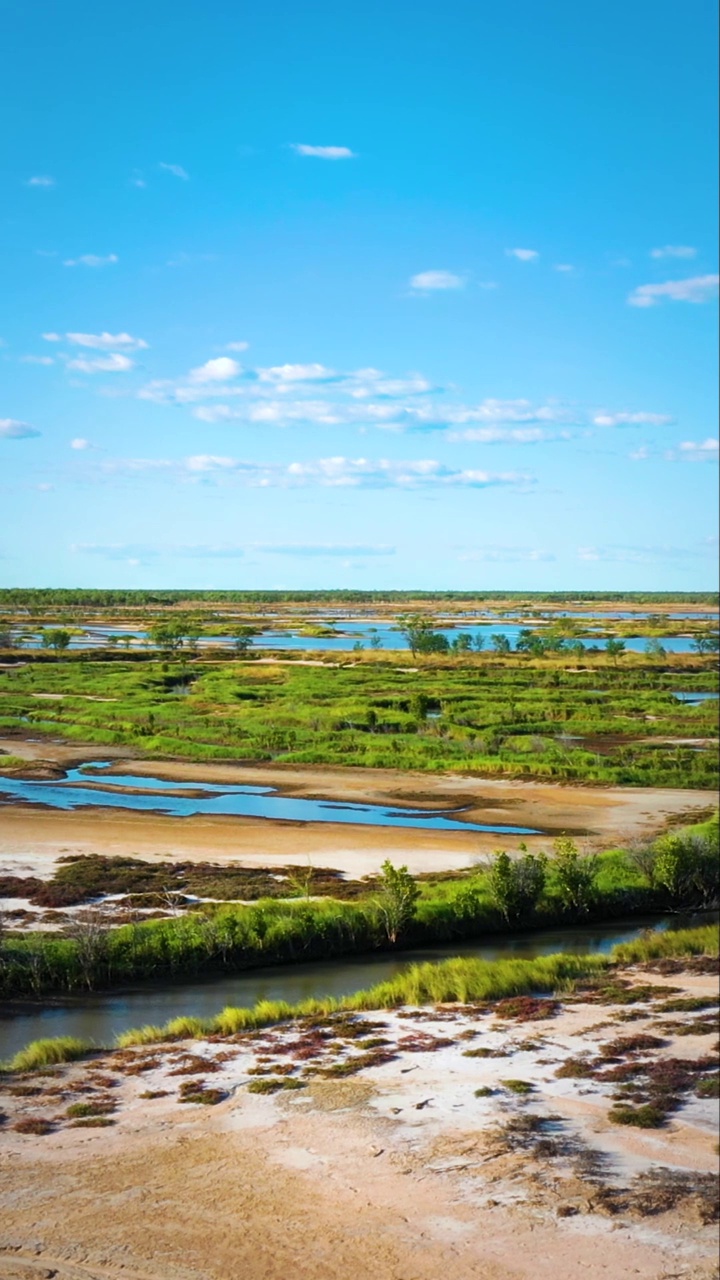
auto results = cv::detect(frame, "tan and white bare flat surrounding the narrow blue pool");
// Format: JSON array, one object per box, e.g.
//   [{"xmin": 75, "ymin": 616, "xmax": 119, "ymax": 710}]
[{"xmin": 0, "ymin": 739, "xmax": 717, "ymax": 877}]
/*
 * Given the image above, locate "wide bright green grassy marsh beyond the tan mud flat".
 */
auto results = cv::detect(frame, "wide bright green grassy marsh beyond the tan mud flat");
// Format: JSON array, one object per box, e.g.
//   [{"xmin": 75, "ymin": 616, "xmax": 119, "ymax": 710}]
[{"xmin": 0, "ymin": 652, "xmax": 717, "ymax": 787}]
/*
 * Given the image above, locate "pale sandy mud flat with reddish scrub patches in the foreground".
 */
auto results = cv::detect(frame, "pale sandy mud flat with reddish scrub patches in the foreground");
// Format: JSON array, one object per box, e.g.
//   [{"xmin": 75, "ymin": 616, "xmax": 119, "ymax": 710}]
[{"xmin": 0, "ymin": 972, "xmax": 717, "ymax": 1280}]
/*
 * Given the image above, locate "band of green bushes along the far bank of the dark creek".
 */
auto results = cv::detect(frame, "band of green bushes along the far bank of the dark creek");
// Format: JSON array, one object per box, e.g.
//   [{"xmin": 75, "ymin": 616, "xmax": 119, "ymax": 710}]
[{"xmin": 0, "ymin": 818, "xmax": 720, "ymax": 997}]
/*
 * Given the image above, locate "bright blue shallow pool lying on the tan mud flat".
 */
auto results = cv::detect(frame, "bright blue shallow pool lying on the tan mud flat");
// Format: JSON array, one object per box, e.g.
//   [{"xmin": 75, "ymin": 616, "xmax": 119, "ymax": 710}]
[{"xmin": 0, "ymin": 763, "xmax": 541, "ymax": 836}]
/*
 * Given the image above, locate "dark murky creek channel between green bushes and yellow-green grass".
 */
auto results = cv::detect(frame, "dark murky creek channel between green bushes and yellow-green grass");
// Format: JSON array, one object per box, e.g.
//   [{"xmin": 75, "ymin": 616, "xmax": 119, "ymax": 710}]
[{"xmin": 0, "ymin": 916, "xmax": 688, "ymax": 1060}]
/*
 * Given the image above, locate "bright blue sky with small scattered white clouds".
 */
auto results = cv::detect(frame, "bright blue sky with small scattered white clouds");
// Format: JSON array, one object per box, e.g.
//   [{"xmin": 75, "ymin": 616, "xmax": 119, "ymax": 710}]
[{"xmin": 0, "ymin": 0, "xmax": 719, "ymax": 591}]
